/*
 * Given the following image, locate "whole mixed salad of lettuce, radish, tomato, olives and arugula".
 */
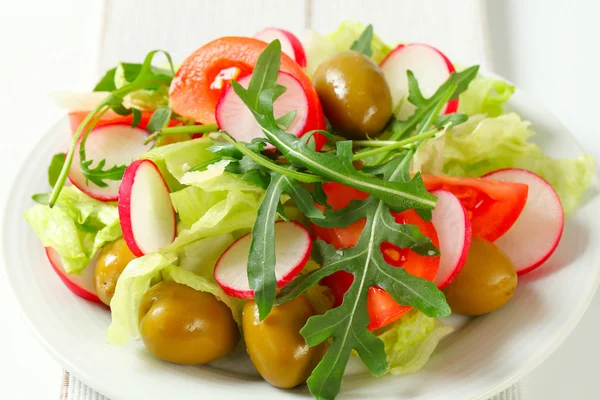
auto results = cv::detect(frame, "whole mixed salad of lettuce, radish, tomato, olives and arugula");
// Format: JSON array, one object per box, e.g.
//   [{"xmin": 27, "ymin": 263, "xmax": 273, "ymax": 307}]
[{"xmin": 24, "ymin": 22, "xmax": 595, "ymax": 399}]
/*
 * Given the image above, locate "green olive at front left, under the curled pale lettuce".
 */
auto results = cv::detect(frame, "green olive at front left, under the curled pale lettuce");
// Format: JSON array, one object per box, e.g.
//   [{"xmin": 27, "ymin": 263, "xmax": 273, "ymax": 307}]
[{"xmin": 139, "ymin": 281, "xmax": 240, "ymax": 364}]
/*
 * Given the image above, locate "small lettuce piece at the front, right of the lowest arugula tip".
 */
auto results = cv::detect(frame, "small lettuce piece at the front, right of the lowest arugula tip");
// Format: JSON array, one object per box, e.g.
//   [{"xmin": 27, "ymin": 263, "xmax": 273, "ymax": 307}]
[{"xmin": 379, "ymin": 310, "xmax": 454, "ymax": 375}]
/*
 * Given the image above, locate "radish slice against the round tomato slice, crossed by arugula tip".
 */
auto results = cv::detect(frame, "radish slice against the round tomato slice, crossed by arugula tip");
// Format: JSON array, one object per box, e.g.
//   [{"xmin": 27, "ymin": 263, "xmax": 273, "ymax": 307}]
[{"xmin": 216, "ymin": 72, "xmax": 308, "ymax": 149}]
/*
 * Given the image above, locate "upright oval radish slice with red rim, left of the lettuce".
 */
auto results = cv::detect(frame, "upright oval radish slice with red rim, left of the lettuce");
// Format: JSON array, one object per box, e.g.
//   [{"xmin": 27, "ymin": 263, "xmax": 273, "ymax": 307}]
[{"xmin": 119, "ymin": 160, "xmax": 177, "ymax": 257}]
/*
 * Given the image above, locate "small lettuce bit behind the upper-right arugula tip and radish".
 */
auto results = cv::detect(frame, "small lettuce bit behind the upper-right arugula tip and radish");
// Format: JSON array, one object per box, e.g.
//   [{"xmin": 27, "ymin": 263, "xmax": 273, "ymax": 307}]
[{"xmin": 458, "ymin": 75, "xmax": 515, "ymax": 117}]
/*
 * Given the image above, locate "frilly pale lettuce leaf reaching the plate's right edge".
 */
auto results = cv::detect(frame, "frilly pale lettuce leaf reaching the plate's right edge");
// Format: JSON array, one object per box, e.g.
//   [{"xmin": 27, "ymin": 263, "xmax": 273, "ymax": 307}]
[{"xmin": 413, "ymin": 113, "xmax": 596, "ymax": 214}]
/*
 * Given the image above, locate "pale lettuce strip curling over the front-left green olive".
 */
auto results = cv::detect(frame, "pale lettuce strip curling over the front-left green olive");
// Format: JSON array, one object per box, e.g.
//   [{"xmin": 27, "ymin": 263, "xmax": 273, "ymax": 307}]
[{"xmin": 107, "ymin": 252, "xmax": 244, "ymax": 346}]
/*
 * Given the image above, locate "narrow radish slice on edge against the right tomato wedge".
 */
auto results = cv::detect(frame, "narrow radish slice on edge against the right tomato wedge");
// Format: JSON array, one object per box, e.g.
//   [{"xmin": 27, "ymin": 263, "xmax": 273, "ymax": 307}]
[{"xmin": 431, "ymin": 190, "xmax": 471, "ymax": 289}]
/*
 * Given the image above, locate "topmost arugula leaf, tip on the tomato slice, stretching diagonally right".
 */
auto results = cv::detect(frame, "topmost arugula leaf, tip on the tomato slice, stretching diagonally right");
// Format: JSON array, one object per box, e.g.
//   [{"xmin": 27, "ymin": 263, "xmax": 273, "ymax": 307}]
[{"xmin": 232, "ymin": 40, "xmax": 435, "ymax": 210}]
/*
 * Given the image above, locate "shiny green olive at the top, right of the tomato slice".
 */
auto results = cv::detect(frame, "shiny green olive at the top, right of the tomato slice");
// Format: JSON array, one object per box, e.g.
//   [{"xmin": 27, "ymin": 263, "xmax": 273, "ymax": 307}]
[{"xmin": 313, "ymin": 50, "xmax": 392, "ymax": 139}]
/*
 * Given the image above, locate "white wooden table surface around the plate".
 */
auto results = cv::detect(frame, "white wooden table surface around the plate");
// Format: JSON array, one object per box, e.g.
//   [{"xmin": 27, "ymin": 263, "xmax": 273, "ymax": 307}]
[{"xmin": 0, "ymin": 0, "xmax": 600, "ymax": 400}]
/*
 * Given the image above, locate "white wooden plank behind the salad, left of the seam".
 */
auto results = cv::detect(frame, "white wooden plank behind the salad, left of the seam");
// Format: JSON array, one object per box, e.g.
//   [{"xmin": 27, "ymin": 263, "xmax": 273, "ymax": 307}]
[{"xmin": 99, "ymin": 0, "xmax": 305, "ymax": 70}]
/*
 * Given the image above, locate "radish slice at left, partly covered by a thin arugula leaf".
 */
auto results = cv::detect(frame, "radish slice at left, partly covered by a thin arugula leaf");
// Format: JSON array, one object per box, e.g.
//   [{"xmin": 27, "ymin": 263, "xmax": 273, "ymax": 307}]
[{"xmin": 69, "ymin": 124, "xmax": 152, "ymax": 201}]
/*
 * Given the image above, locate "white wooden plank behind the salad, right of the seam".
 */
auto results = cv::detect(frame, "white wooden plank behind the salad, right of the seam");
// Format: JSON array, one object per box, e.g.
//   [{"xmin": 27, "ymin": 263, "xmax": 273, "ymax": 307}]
[{"xmin": 307, "ymin": 0, "xmax": 487, "ymax": 65}]
